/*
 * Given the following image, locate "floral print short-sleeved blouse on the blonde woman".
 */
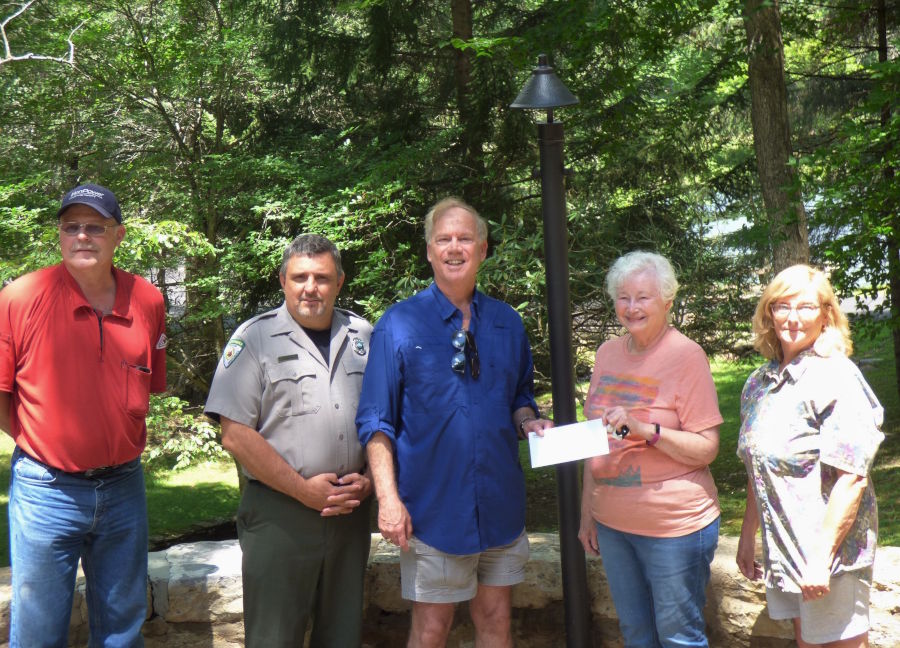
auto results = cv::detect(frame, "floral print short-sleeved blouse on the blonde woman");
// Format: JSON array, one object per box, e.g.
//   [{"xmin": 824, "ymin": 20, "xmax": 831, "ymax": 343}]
[{"xmin": 737, "ymin": 349, "xmax": 884, "ymax": 592}]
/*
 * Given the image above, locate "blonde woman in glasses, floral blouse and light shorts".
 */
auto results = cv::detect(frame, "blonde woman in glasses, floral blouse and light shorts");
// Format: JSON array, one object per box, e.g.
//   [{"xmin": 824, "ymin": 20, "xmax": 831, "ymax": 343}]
[{"xmin": 737, "ymin": 265, "xmax": 884, "ymax": 648}]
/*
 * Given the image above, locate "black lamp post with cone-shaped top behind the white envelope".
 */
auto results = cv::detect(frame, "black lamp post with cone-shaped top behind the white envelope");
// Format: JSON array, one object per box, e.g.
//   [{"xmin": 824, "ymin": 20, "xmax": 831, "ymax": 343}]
[{"xmin": 510, "ymin": 54, "xmax": 593, "ymax": 648}]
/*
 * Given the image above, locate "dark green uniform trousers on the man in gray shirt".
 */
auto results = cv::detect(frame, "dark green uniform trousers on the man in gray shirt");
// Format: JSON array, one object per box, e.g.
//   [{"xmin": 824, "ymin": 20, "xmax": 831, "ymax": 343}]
[{"xmin": 237, "ymin": 480, "xmax": 372, "ymax": 648}]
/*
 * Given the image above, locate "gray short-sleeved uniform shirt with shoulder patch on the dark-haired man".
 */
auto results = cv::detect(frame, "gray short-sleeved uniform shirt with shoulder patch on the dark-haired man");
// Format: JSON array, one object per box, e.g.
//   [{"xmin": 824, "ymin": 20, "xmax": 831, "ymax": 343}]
[{"xmin": 205, "ymin": 304, "xmax": 372, "ymax": 479}]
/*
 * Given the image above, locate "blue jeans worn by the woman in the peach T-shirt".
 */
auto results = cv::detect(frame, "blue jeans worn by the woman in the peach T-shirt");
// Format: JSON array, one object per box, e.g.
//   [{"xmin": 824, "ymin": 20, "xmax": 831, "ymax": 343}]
[{"xmin": 597, "ymin": 518, "xmax": 719, "ymax": 648}]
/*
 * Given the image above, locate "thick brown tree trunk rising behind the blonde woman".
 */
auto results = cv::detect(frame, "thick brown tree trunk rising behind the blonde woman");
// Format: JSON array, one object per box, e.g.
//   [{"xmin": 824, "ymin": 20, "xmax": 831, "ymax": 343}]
[{"xmin": 744, "ymin": 0, "xmax": 809, "ymax": 272}]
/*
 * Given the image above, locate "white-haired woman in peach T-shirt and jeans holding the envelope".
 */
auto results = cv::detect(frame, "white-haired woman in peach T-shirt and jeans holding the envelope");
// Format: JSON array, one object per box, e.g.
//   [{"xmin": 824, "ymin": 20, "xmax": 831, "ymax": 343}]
[{"xmin": 578, "ymin": 252, "xmax": 722, "ymax": 648}]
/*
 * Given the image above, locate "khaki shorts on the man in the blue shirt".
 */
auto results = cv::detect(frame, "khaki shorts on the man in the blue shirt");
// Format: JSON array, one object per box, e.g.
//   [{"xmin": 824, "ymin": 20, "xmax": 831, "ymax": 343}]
[{"xmin": 400, "ymin": 531, "xmax": 528, "ymax": 603}]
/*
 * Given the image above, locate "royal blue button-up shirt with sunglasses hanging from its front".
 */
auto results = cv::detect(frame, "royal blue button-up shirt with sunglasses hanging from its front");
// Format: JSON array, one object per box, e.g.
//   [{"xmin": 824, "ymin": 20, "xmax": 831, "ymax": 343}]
[{"xmin": 356, "ymin": 284, "xmax": 537, "ymax": 555}]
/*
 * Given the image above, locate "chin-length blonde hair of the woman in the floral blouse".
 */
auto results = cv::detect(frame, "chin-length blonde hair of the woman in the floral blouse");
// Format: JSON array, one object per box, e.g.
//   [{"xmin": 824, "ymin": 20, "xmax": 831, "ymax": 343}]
[{"xmin": 753, "ymin": 264, "xmax": 853, "ymax": 361}]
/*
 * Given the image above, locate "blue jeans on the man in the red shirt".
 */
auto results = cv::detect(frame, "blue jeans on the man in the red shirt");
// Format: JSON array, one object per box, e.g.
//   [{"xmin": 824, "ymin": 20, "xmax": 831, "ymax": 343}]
[{"xmin": 9, "ymin": 448, "xmax": 147, "ymax": 648}]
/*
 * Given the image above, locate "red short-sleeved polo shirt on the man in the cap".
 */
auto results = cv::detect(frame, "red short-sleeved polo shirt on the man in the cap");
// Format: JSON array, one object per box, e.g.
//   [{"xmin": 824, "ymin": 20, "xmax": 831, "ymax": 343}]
[{"xmin": 0, "ymin": 264, "xmax": 166, "ymax": 472}]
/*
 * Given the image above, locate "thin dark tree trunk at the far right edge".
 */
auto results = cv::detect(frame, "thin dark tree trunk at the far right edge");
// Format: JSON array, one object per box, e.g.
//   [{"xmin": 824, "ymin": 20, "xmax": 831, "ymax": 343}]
[{"xmin": 875, "ymin": 0, "xmax": 900, "ymax": 402}]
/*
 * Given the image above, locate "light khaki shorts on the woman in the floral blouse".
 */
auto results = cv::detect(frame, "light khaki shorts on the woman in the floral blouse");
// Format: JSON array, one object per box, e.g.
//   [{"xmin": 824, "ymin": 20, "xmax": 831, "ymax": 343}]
[{"xmin": 766, "ymin": 568, "xmax": 872, "ymax": 644}]
